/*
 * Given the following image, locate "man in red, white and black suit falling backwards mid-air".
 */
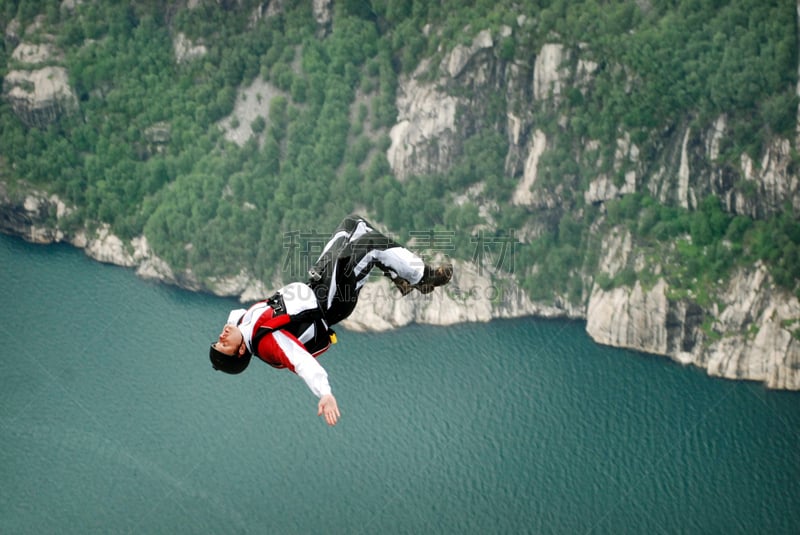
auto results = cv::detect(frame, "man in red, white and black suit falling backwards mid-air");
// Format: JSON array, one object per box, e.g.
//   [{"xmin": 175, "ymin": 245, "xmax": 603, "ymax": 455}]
[{"xmin": 209, "ymin": 215, "xmax": 453, "ymax": 425}]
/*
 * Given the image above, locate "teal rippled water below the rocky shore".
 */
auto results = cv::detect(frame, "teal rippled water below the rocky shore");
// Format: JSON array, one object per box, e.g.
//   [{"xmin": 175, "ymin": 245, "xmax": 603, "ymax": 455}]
[{"xmin": 0, "ymin": 236, "xmax": 800, "ymax": 534}]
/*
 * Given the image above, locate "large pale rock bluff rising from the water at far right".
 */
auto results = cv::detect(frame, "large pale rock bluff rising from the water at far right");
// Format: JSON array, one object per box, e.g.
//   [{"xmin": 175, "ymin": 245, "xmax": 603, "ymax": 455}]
[{"xmin": 586, "ymin": 266, "xmax": 800, "ymax": 390}]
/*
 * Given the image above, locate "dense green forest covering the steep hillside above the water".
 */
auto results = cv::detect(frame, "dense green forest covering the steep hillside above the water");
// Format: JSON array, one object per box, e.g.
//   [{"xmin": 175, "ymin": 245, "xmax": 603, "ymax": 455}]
[{"xmin": 0, "ymin": 0, "xmax": 800, "ymax": 300}]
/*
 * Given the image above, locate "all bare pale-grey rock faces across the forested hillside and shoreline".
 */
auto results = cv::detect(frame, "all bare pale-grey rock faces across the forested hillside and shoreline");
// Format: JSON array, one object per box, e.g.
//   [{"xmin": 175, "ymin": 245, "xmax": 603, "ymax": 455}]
[{"xmin": 0, "ymin": 1, "xmax": 800, "ymax": 389}]
